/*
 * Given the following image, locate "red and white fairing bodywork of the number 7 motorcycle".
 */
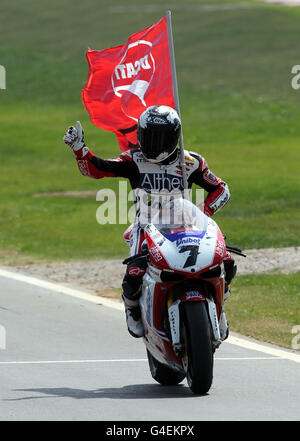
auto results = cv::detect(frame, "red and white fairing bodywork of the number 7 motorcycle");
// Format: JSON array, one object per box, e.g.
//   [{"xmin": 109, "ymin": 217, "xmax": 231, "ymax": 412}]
[{"xmin": 140, "ymin": 199, "xmax": 226, "ymax": 371}]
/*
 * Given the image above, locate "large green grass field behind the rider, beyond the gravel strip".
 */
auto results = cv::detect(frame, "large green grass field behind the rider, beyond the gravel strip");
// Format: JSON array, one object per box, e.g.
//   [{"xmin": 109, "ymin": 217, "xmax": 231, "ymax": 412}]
[{"xmin": 0, "ymin": 0, "xmax": 300, "ymax": 264}]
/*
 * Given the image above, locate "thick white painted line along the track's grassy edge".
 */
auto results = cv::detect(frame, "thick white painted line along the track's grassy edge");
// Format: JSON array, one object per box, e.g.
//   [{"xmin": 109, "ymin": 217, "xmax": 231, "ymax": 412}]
[{"xmin": 0, "ymin": 268, "xmax": 300, "ymax": 363}]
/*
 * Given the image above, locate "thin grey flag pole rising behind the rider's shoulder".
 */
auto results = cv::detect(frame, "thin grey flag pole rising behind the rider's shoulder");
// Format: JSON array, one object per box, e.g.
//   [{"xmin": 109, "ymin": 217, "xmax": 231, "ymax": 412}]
[{"xmin": 166, "ymin": 11, "xmax": 188, "ymax": 197}]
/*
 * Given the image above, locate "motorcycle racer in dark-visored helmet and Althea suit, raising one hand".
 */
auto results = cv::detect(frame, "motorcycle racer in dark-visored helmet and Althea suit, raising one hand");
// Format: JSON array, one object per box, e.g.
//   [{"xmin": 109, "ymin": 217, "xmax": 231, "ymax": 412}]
[{"xmin": 63, "ymin": 105, "xmax": 236, "ymax": 339}]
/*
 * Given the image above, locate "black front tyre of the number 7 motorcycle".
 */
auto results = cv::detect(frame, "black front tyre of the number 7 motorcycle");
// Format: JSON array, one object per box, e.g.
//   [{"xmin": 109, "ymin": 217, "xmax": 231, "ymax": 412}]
[{"xmin": 182, "ymin": 301, "xmax": 214, "ymax": 395}]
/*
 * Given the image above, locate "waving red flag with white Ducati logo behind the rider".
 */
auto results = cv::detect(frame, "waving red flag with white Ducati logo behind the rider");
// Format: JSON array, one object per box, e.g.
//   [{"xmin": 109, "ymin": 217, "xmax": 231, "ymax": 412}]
[{"xmin": 82, "ymin": 17, "xmax": 175, "ymax": 151}]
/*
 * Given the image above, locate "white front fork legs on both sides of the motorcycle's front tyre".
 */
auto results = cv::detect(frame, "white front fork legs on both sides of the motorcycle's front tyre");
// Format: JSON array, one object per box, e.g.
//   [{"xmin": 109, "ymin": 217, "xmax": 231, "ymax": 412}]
[{"xmin": 168, "ymin": 294, "xmax": 221, "ymax": 358}]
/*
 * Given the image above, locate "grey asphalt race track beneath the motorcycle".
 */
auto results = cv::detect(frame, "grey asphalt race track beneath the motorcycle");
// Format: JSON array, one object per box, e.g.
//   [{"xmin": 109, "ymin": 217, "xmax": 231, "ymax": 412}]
[{"xmin": 0, "ymin": 269, "xmax": 300, "ymax": 421}]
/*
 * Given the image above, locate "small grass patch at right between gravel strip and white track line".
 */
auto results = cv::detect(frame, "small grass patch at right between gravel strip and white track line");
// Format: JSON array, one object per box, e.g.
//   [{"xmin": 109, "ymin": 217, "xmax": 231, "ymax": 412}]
[{"xmin": 226, "ymin": 272, "xmax": 300, "ymax": 349}]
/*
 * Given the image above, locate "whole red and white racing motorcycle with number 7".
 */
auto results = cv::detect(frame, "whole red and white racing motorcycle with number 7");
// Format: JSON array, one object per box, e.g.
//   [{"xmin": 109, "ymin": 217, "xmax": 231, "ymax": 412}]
[{"xmin": 124, "ymin": 199, "xmax": 241, "ymax": 394}]
